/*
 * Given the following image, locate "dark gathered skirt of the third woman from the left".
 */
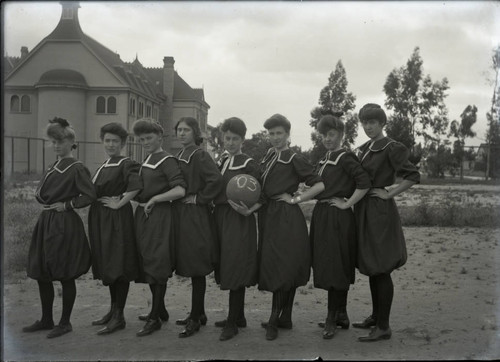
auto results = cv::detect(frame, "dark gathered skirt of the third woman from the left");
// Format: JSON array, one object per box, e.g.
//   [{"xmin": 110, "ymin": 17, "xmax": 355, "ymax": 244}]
[{"xmin": 135, "ymin": 202, "xmax": 175, "ymax": 284}]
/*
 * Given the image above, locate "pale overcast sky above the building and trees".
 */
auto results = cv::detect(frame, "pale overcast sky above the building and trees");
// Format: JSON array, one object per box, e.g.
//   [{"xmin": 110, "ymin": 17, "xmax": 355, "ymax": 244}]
[{"xmin": 2, "ymin": 1, "xmax": 500, "ymax": 149}]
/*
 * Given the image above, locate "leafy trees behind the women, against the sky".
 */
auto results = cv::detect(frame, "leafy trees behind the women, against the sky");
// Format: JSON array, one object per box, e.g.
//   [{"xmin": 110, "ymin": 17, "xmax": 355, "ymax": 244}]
[{"xmin": 208, "ymin": 46, "xmax": 500, "ymax": 179}]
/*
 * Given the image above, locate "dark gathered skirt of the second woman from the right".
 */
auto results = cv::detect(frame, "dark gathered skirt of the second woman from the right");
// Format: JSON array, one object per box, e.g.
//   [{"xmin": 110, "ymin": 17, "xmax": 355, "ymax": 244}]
[{"xmin": 309, "ymin": 202, "xmax": 356, "ymax": 290}]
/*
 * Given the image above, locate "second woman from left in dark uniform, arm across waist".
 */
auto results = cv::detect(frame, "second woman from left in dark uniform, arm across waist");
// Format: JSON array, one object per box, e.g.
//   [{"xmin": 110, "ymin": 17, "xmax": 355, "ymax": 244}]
[{"xmin": 89, "ymin": 123, "xmax": 141, "ymax": 334}]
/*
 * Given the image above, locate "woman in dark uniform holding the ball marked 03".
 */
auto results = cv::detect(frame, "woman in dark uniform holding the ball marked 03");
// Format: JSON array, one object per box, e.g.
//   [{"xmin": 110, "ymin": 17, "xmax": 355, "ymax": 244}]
[{"xmin": 214, "ymin": 117, "xmax": 259, "ymax": 341}]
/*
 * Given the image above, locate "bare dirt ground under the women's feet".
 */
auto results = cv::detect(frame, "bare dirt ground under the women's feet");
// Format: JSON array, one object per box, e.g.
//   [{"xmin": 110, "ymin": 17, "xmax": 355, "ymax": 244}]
[{"xmin": 3, "ymin": 227, "xmax": 500, "ymax": 360}]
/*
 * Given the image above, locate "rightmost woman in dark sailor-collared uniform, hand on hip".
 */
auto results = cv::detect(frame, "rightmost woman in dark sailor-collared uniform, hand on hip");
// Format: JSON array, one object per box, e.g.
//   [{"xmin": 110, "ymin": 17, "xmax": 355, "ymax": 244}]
[{"xmin": 353, "ymin": 103, "xmax": 420, "ymax": 342}]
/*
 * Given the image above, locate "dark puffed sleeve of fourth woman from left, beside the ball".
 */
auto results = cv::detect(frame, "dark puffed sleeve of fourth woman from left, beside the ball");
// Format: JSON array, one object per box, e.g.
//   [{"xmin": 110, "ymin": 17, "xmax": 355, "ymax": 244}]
[{"xmin": 194, "ymin": 151, "xmax": 223, "ymax": 204}]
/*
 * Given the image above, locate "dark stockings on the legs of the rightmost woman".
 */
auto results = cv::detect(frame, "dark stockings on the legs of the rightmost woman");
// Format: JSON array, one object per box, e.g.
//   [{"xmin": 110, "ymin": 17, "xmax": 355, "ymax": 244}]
[{"xmin": 370, "ymin": 274, "xmax": 394, "ymax": 329}]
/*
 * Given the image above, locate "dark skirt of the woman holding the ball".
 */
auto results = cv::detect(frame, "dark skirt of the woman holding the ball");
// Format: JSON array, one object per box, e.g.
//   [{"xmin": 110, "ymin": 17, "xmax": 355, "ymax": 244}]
[{"xmin": 215, "ymin": 204, "xmax": 257, "ymax": 290}]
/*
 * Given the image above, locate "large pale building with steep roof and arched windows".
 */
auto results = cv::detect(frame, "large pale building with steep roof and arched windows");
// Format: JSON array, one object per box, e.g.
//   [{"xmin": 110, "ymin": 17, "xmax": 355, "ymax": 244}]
[{"xmin": 3, "ymin": 2, "xmax": 210, "ymax": 171}]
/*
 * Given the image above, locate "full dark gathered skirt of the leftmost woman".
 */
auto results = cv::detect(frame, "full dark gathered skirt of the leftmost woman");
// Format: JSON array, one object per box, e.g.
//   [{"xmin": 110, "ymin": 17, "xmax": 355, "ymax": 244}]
[{"xmin": 27, "ymin": 210, "xmax": 90, "ymax": 282}]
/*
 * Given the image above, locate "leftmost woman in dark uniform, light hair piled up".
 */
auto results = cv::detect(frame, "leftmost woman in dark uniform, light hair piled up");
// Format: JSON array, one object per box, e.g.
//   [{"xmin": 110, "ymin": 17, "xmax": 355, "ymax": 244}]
[{"xmin": 23, "ymin": 117, "xmax": 96, "ymax": 338}]
